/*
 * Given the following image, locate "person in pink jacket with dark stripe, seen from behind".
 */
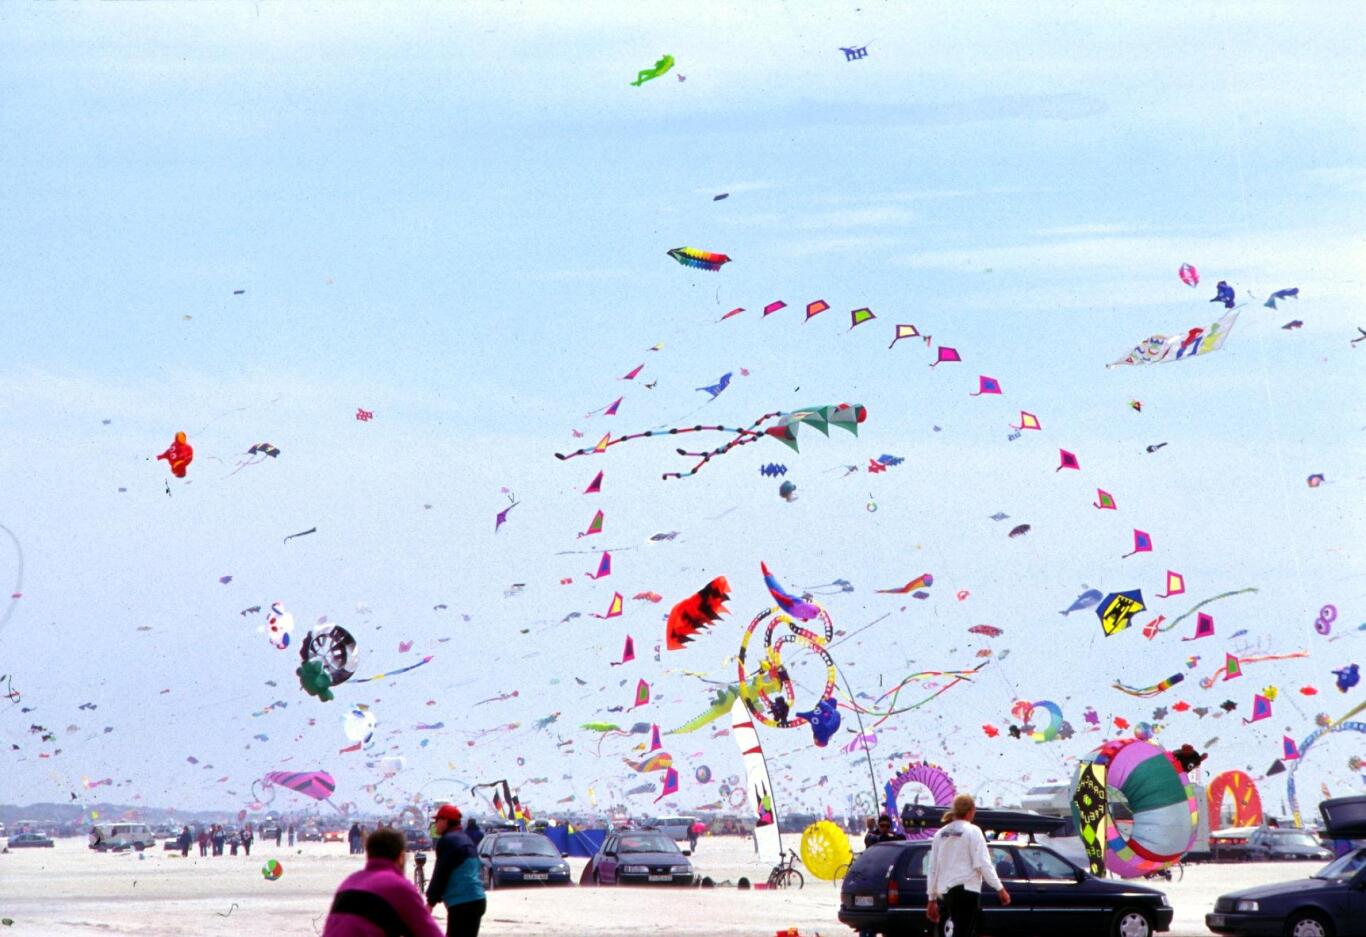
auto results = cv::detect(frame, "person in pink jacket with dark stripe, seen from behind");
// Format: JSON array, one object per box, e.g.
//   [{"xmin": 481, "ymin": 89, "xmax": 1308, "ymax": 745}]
[{"xmin": 322, "ymin": 829, "xmax": 444, "ymax": 937}]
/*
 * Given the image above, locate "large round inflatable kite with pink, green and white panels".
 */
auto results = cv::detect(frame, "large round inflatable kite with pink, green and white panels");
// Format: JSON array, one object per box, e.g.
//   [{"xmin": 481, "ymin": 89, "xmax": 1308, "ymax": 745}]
[{"xmin": 1072, "ymin": 738, "xmax": 1199, "ymax": 878}]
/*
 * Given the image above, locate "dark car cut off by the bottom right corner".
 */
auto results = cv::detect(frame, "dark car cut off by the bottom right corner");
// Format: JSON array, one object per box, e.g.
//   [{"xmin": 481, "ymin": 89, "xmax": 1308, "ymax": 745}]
[{"xmin": 1205, "ymin": 848, "xmax": 1366, "ymax": 937}]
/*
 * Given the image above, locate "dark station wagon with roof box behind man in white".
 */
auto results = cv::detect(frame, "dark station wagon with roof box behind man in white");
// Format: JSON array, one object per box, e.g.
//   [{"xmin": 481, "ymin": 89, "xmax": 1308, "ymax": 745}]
[{"xmin": 839, "ymin": 841, "xmax": 1172, "ymax": 937}]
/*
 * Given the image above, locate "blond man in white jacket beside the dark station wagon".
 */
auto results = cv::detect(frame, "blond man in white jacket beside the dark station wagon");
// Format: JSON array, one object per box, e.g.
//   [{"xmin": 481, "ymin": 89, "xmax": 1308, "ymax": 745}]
[{"xmin": 925, "ymin": 794, "xmax": 1011, "ymax": 937}]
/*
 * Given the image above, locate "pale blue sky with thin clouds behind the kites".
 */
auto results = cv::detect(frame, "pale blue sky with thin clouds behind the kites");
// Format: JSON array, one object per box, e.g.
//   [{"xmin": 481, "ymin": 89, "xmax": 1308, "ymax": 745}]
[{"xmin": 0, "ymin": 0, "xmax": 1366, "ymax": 813}]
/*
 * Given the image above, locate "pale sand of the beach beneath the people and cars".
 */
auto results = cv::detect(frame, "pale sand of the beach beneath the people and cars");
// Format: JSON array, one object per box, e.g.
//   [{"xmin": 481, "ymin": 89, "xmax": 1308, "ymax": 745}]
[{"xmin": 0, "ymin": 837, "xmax": 1318, "ymax": 937}]
